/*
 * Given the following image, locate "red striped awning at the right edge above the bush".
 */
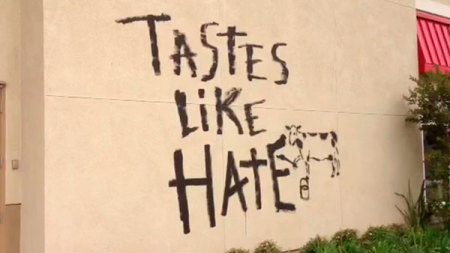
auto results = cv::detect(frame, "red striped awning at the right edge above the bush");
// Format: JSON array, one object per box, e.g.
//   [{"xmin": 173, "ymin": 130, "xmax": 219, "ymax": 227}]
[{"xmin": 417, "ymin": 11, "xmax": 450, "ymax": 74}]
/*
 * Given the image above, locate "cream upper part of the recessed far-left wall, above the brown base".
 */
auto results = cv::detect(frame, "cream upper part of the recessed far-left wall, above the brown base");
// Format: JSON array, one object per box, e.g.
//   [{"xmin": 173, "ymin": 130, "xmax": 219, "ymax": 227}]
[{"xmin": 0, "ymin": 0, "xmax": 21, "ymax": 204}]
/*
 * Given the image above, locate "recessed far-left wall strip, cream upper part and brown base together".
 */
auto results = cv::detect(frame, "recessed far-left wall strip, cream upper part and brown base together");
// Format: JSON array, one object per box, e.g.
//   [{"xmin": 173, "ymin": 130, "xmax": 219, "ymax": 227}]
[{"xmin": 0, "ymin": 0, "xmax": 21, "ymax": 253}]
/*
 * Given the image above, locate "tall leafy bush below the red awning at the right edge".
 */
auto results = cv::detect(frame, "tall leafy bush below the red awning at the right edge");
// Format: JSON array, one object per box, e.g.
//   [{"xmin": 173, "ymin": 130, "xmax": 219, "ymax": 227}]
[{"xmin": 404, "ymin": 67, "xmax": 450, "ymax": 211}]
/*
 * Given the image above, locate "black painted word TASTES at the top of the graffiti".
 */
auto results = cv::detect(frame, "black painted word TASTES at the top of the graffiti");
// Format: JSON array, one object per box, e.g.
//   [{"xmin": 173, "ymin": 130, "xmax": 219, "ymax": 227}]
[{"xmin": 116, "ymin": 13, "xmax": 289, "ymax": 85}]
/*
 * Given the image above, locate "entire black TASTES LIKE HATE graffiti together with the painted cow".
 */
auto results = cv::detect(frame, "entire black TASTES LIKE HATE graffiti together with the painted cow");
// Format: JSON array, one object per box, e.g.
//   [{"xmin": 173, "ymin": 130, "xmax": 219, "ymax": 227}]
[{"xmin": 116, "ymin": 14, "xmax": 340, "ymax": 234}]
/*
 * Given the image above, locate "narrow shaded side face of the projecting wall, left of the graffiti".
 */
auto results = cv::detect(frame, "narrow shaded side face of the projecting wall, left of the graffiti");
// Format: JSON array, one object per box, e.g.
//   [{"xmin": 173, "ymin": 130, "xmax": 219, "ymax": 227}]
[{"xmin": 20, "ymin": 0, "xmax": 45, "ymax": 253}]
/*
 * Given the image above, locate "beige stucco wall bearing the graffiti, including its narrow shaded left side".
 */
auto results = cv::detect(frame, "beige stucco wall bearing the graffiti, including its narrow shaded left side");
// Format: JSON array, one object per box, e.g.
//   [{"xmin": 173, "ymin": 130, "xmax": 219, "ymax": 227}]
[{"xmin": 16, "ymin": 0, "xmax": 422, "ymax": 253}]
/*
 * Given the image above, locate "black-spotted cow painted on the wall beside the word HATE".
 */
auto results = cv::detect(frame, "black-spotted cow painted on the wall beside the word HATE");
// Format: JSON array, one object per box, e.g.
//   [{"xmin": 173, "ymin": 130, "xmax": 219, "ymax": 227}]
[{"xmin": 277, "ymin": 125, "xmax": 340, "ymax": 177}]
